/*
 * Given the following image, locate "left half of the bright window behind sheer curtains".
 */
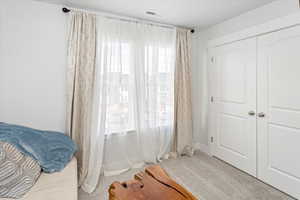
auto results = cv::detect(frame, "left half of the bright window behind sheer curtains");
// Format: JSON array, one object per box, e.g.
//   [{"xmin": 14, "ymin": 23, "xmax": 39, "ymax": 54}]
[{"xmin": 106, "ymin": 43, "xmax": 134, "ymax": 134}]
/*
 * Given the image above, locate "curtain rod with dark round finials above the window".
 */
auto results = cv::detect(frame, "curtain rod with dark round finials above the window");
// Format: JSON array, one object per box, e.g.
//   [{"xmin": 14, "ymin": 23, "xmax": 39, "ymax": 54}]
[{"xmin": 62, "ymin": 7, "xmax": 195, "ymax": 33}]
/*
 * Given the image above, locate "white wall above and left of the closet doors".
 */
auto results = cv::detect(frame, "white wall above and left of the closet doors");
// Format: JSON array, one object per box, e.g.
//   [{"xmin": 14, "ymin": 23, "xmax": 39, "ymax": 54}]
[{"xmin": 192, "ymin": 0, "xmax": 300, "ymax": 150}]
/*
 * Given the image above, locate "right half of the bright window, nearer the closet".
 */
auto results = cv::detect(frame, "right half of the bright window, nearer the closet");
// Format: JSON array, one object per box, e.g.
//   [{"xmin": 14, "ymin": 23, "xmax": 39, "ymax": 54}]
[{"xmin": 145, "ymin": 46, "xmax": 174, "ymax": 127}]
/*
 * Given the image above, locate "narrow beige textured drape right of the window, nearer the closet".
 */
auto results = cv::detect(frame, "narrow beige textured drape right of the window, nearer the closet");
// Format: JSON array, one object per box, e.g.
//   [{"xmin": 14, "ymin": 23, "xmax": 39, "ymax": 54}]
[{"xmin": 173, "ymin": 28, "xmax": 193, "ymax": 155}]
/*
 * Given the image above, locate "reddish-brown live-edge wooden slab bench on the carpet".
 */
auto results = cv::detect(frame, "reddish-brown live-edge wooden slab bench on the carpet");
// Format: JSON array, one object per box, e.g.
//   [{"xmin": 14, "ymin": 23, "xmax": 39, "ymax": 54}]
[{"xmin": 109, "ymin": 165, "xmax": 197, "ymax": 200}]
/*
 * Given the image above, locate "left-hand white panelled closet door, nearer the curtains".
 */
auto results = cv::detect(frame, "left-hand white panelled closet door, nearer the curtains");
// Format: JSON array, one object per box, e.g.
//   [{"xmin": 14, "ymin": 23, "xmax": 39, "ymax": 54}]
[{"xmin": 213, "ymin": 39, "xmax": 256, "ymax": 176}]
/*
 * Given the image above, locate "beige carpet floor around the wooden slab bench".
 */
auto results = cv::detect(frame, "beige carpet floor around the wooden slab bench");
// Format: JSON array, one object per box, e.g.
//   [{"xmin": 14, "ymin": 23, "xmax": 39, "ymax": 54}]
[{"xmin": 79, "ymin": 153, "xmax": 293, "ymax": 200}]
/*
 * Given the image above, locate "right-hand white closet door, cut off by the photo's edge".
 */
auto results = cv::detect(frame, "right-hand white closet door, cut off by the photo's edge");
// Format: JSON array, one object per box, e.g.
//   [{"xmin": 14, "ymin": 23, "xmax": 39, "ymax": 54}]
[{"xmin": 258, "ymin": 26, "xmax": 300, "ymax": 199}]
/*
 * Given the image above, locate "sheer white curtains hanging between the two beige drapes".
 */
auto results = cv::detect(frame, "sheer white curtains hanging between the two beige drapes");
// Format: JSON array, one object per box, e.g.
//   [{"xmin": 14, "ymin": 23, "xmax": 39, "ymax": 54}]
[{"xmin": 83, "ymin": 17, "xmax": 176, "ymax": 192}]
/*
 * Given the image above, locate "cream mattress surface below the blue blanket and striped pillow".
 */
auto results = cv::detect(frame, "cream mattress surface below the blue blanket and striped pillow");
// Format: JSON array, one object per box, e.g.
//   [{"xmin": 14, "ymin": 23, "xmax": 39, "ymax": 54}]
[{"xmin": 0, "ymin": 158, "xmax": 77, "ymax": 200}]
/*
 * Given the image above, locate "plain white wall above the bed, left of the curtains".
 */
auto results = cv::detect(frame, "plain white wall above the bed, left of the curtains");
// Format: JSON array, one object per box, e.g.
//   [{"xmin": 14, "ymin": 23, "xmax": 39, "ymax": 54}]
[{"xmin": 0, "ymin": 0, "xmax": 66, "ymax": 131}]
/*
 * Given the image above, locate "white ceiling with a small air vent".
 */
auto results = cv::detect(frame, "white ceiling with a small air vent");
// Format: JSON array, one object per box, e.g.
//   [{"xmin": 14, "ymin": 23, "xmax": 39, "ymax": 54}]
[{"xmin": 39, "ymin": 0, "xmax": 274, "ymax": 28}]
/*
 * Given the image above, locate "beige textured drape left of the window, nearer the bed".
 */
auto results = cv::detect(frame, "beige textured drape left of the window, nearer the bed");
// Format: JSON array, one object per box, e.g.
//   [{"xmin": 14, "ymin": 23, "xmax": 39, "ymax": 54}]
[{"xmin": 67, "ymin": 11, "xmax": 96, "ymax": 185}]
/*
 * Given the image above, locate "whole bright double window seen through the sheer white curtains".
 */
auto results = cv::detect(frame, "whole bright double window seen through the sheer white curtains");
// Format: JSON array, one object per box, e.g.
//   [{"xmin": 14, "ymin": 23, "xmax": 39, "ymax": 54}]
[{"xmin": 101, "ymin": 42, "xmax": 174, "ymax": 134}]
